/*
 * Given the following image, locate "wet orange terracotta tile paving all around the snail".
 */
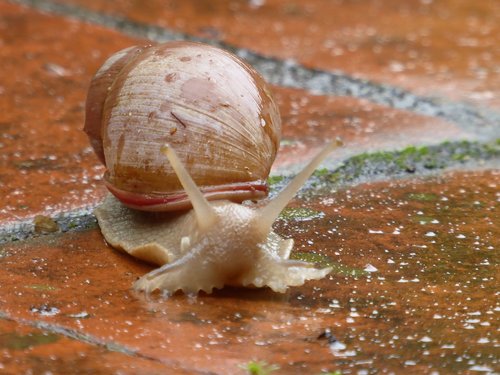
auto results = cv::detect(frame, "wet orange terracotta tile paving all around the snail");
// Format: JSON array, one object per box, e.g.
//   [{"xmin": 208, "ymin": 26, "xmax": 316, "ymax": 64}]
[{"xmin": 0, "ymin": 0, "xmax": 500, "ymax": 374}]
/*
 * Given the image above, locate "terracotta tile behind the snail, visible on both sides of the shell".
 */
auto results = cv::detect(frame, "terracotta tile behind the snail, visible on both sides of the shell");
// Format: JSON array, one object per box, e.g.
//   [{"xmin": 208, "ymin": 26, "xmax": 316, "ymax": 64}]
[{"xmin": 0, "ymin": 3, "xmax": 467, "ymax": 229}]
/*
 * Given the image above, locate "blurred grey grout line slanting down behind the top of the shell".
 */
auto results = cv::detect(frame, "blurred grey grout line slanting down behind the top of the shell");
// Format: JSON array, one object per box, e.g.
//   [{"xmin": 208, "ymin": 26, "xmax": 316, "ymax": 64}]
[{"xmin": 6, "ymin": 0, "xmax": 500, "ymax": 140}]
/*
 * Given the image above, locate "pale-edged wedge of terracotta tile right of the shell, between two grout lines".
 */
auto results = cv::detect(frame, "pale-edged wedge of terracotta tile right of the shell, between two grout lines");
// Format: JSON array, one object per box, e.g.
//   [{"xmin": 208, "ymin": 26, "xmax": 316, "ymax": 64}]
[{"xmin": 274, "ymin": 87, "xmax": 468, "ymax": 173}]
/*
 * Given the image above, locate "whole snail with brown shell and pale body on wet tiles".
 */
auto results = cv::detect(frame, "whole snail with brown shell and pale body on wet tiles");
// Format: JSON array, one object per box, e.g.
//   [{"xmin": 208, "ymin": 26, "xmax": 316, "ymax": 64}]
[{"xmin": 84, "ymin": 42, "xmax": 337, "ymax": 294}]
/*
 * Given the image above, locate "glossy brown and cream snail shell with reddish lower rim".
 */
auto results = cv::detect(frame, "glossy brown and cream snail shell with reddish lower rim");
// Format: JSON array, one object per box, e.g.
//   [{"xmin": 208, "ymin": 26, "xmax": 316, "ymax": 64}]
[{"xmin": 84, "ymin": 42, "xmax": 281, "ymax": 211}]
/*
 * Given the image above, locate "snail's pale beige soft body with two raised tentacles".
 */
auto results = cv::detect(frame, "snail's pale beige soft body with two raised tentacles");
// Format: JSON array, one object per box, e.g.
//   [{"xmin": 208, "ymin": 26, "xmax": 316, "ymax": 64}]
[{"xmin": 95, "ymin": 142, "xmax": 336, "ymax": 294}]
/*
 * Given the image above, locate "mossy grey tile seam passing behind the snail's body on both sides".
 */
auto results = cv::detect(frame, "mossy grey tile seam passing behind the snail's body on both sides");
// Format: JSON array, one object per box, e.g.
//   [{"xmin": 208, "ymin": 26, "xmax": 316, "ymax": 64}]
[{"xmin": 0, "ymin": 138, "xmax": 500, "ymax": 245}]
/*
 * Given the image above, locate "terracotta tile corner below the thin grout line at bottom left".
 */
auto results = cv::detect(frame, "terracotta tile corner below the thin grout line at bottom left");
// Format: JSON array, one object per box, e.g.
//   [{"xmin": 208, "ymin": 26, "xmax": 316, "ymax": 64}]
[{"xmin": 0, "ymin": 318, "xmax": 185, "ymax": 374}]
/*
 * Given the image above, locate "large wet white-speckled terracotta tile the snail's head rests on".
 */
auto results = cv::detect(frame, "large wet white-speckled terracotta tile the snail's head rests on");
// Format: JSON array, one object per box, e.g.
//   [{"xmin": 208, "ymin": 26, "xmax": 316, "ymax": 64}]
[{"xmin": 0, "ymin": 171, "xmax": 500, "ymax": 374}]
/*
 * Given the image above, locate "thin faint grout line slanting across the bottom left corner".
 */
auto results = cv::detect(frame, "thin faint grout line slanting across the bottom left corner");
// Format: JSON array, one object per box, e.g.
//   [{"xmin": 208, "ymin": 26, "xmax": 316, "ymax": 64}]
[{"xmin": 0, "ymin": 311, "xmax": 207, "ymax": 374}]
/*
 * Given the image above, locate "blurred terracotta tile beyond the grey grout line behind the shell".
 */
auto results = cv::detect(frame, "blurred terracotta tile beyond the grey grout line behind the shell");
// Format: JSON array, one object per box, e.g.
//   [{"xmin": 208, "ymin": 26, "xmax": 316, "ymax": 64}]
[{"xmin": 53, "ymin": 0, "xmax": 500, "ymax": 108}]
